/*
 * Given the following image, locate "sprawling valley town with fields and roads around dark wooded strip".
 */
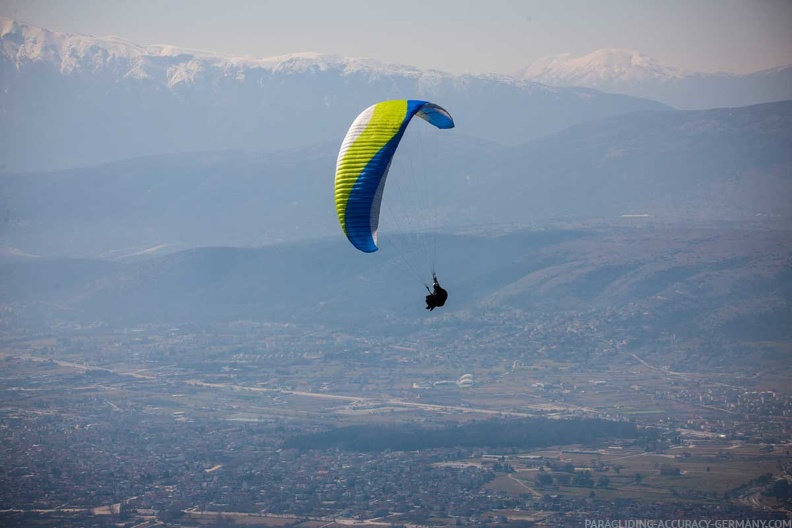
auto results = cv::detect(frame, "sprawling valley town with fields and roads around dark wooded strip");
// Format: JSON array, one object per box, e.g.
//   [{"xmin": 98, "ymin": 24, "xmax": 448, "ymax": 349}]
[{"xmin": 0, "ymin": 304, "xmax": 792, "ymax": 526}]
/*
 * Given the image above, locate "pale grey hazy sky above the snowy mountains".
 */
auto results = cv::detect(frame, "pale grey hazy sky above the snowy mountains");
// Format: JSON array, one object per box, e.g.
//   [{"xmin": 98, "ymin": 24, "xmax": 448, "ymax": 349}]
[{"xmin": 0, "ymin": 0, "xmax": 792, "ymax": 74}]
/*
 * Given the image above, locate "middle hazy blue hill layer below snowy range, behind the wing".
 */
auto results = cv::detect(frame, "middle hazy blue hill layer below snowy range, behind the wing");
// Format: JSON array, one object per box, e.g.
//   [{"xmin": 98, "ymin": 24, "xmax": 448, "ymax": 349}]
[{"xmin": 0, "ymin": 102, "xmax": 792, "ymax": 258}]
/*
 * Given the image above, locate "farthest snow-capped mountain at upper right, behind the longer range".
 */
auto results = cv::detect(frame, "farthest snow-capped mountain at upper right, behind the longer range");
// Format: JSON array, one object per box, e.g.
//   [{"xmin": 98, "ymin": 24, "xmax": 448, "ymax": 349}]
[{"xmin": 516, "ymin": 49, "xmax": 792, "ymax": 109}]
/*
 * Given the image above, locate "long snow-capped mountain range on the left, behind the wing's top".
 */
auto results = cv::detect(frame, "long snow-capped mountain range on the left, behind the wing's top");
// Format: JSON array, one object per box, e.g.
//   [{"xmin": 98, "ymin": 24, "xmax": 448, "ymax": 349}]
[{"xmin": 0, "ymin": 18, "xmax": 667, "ymax": 170}]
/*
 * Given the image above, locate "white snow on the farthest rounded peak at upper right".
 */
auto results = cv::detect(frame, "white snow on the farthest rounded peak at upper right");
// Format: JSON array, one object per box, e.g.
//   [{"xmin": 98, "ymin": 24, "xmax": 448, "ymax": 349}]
[{"xmin": 517, "ymin": 48, "xmax": 687, "ymax": 87}]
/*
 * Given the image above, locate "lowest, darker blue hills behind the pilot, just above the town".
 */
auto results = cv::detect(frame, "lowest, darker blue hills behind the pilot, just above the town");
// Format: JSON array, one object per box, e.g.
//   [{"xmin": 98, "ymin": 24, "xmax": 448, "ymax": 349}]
[{"xmin": 0, "ymin": 223, "xmax": 792, "ymax": 346}]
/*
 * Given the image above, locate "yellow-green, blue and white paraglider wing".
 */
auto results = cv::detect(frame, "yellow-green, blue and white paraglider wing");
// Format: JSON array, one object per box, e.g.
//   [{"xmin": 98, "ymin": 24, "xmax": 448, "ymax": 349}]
[{"xmin": 335, "ymin": 100, "xmax": 454, "ymax": 253}]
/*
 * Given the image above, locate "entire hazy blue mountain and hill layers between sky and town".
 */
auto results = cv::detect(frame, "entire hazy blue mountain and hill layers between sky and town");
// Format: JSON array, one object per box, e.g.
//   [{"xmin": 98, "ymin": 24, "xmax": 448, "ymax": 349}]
[{"xmin": 0, "ymin": 19, "xmax": 792, "ymax": 364}]
